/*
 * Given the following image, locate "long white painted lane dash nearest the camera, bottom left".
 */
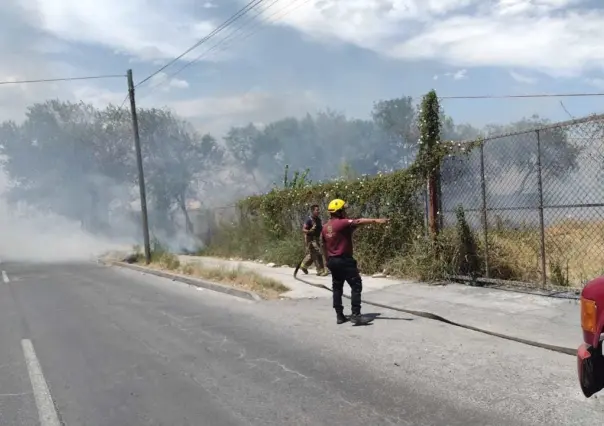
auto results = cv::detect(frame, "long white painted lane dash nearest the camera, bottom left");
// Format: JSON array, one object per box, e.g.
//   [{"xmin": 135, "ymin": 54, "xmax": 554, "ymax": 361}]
[{"xmin": 21, "ymin": 339, "xmax": 61, "ymax": 426}]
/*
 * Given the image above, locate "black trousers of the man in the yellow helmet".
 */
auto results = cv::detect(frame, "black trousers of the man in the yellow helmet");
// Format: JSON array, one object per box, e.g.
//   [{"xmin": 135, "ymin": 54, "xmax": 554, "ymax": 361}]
[{"xmin": 327, "ymin": 257, "xmax": 363, "ymax": 315}]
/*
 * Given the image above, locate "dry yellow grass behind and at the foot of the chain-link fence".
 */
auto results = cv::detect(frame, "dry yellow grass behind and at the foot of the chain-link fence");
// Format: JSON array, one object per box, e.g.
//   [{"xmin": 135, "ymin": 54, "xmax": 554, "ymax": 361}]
[{"xmin": 384, "ymin": 220, "xmax": 604, "ymax": 287}]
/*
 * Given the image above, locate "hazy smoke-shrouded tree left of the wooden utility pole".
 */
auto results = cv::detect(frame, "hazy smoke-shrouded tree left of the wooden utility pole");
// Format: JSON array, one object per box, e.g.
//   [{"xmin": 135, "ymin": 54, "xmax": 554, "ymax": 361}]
[{"xmin": 0, "ymin": 100, "xmax": 127, "ymax": 231}]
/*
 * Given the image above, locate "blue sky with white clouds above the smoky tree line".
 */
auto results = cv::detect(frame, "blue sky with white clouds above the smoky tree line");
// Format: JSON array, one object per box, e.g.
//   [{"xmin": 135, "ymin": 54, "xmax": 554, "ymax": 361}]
[{"xmin": 0, "ymin": 0, "xmax": 604, "ymax": 134}]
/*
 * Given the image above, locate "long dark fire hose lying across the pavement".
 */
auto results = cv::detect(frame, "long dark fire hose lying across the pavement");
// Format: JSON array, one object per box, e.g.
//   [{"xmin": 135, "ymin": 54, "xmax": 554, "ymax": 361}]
[{"xmin": 294, "ymin": 268, "xmax": 577, "ymax": 356}]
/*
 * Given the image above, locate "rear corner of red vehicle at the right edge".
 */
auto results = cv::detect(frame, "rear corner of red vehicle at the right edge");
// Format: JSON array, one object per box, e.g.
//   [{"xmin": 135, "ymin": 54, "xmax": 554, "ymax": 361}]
[{"xmin": 577, "ymin": 276, "xmax": 604, "ymax": 398}]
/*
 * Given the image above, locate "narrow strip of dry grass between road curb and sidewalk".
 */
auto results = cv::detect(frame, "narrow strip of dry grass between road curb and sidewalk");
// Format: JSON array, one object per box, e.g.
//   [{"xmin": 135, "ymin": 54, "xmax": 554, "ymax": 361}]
[{"xmin": 136, "ymin": 253, "xmax": 290, "ymax": 299}]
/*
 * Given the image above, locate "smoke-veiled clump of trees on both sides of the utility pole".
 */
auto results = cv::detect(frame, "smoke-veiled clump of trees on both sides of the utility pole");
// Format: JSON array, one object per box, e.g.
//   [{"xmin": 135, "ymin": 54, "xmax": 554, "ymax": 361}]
[{"xmin": 0, "ymin": 101, "xmax": 224, "ymax": 243}]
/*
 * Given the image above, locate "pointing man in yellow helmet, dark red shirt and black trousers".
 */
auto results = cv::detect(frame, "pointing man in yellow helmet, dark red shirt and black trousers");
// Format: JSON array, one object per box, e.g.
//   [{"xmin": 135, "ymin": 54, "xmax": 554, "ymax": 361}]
[{"xmin": 321, "ymin": 199, "xmax": 388, "ymax": 325}]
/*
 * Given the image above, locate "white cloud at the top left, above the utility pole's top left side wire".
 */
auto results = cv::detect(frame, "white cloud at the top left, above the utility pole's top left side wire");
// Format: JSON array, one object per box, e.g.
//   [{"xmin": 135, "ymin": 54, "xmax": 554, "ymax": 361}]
[{"xmin": 22, "ymin": 0, "xmax": 217, "ymax": 61}]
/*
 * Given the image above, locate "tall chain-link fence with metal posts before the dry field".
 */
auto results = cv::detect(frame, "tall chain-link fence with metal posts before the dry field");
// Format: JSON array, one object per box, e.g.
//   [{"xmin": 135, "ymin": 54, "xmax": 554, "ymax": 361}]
[{"xmin": 441, "ymin": 111, "xmax": 604, "ymax": 286}]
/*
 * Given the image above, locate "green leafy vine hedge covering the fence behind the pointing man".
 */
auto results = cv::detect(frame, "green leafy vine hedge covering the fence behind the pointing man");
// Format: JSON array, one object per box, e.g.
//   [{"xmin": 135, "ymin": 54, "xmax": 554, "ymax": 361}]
[{"xmin": 210, "ymin": 91, "xmax": 478, "ymax": 272}]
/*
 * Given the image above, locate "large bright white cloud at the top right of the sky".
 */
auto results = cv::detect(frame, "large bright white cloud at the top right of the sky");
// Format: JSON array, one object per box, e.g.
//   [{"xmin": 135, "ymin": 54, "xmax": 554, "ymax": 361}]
[{"xmin": 276, "ymin": 0, "xmax": 604, "ymax": 77}]
